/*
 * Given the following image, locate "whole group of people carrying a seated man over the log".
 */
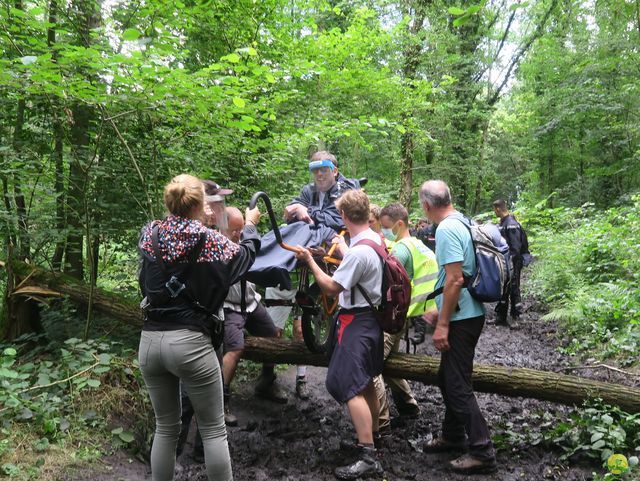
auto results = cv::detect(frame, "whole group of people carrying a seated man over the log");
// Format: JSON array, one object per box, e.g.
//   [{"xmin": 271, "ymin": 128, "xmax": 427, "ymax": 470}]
[{"xmin": 139, "ymin": 151, "xmax": 526, "ymax": 481}]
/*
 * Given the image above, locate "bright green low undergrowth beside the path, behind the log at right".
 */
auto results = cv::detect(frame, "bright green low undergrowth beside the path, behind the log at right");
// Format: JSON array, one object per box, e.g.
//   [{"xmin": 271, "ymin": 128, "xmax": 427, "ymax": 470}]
[{"xmin": 521, "ymin": 197, "xmax": 640, "ymax": 365}]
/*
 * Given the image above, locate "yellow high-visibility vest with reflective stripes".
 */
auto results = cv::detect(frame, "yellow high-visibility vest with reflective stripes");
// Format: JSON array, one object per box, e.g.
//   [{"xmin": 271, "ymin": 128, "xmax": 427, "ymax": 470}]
[{"xmin": 398, "ymin": 237, "xmax": 438, "ymax": 317}]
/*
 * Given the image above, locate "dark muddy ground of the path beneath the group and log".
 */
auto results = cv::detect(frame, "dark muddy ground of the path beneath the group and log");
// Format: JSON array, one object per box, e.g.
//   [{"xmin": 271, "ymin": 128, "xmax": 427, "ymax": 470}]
[{"xmin": 68, "ymin": 305, "xmax": 617, "ymax": 481}]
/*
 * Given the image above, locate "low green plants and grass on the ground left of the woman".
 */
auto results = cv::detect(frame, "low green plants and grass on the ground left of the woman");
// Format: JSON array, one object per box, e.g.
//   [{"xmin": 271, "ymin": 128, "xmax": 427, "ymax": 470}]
[{"xmin": 0, "ymin": 336, "xmax": 152, "ymax": 479}]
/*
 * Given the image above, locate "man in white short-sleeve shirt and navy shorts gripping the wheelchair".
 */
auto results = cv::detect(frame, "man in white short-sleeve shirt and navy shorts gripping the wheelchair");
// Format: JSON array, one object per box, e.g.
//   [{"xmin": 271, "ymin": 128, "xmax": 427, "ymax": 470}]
[{"xmin": 297, "ymin": 190, "xmax": 384, "ymax": 479}]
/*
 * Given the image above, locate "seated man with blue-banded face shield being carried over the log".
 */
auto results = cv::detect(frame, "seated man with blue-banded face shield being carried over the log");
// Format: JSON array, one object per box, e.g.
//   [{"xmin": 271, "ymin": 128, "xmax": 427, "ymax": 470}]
[{"xmin": 284, "ymin": 150, "xmax": 359, "ymax": 230}]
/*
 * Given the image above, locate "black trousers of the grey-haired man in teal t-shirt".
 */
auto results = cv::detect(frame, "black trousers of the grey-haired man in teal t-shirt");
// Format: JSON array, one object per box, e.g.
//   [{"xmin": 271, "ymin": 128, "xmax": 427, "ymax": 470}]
[{"xmin": 438, "ymin": 316, "xmax": 495, "ymax": 459}]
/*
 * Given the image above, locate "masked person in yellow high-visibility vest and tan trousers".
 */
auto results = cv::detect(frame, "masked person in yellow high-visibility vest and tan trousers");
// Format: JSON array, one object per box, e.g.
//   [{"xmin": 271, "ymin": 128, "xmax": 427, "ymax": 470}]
[{"xmin": 374, "ymin": 203, "xmax": 438, "ymax": 431}]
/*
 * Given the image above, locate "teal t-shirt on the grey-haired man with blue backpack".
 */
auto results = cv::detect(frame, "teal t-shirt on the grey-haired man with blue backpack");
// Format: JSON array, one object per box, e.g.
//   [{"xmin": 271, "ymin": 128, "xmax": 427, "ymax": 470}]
[{"xmin": 435, "ymin": 212, "xmax": 484, "ymax": 321}]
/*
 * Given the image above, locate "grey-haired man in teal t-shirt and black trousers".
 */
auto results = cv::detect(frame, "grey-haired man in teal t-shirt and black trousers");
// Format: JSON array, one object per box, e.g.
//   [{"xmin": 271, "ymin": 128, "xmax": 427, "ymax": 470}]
[{"xmin": 420, "ymin": 180, "xmax": 496, "ymax": 474}]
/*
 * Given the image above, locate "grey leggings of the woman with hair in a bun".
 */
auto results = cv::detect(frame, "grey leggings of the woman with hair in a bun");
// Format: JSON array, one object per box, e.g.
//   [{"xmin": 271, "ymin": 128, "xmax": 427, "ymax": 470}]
[{"xmin": 138, "ymin": 329, "xmax": 233, "ymax": 481}]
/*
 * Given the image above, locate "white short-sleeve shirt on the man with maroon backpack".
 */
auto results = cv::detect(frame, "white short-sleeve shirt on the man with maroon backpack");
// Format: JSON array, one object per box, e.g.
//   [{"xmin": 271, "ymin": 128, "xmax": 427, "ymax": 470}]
[{"xmin": 333, "ymin": 229, "xmax": 382, "ymax": 309}]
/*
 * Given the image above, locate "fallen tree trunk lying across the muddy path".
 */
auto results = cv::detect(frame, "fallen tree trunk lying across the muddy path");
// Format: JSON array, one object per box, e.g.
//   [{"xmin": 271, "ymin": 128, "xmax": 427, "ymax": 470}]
[{"xmin": 5, "ymin": 262, "xmax": 640, "ymax": 413}]
